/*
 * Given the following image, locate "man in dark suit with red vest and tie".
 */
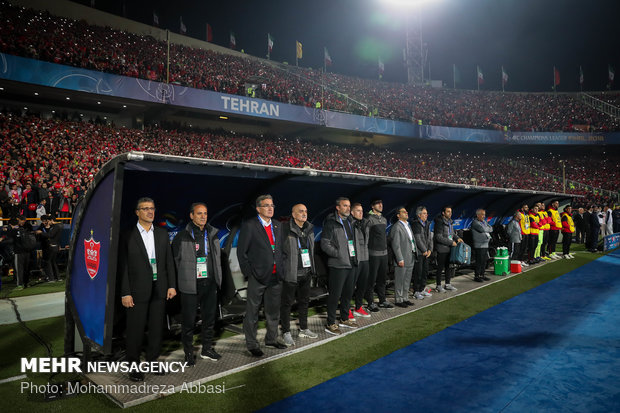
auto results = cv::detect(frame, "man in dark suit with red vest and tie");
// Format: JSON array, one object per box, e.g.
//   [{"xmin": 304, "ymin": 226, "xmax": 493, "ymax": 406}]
[{"xmin": 237, "ymin": 195, "xmax": 286, "ymax": 357}]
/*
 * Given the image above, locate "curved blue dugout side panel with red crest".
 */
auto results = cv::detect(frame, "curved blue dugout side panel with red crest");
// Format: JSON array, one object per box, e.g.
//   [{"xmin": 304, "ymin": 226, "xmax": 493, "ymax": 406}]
[{"xmin": 70, "ymin": 171, "xmax": 114, "ymax": 347}]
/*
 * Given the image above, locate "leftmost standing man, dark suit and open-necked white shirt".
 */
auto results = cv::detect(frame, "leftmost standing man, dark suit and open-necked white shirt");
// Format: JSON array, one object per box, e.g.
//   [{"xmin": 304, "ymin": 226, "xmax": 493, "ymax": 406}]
[{"xmin": 119, "ymin": 198, "xmax": 176, "ymax": 381}]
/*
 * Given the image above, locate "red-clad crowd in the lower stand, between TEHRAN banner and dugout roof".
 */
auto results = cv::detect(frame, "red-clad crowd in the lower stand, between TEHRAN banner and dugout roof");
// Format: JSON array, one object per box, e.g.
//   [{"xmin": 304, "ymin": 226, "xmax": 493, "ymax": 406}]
[{"xmin": 0, "ymin": 112, "xmax": 620, "ymax": 222}]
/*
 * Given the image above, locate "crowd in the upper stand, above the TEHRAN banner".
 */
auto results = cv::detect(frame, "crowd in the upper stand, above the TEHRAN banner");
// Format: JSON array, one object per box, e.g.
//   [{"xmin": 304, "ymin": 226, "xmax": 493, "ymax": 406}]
[{"xmin": 0, "ymin": 2, "xmax": 620, "ymax": 131}]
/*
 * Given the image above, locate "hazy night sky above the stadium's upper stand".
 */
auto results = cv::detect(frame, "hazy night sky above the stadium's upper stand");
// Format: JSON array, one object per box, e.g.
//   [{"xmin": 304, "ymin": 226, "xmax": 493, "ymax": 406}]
[{"xmin": 78, "ymin": 0, "xmax": 620, "ymax": 92}]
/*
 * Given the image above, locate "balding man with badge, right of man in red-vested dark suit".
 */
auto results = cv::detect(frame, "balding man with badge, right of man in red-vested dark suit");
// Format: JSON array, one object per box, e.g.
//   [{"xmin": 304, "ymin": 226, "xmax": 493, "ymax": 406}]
[{"xmin": 280, "ymin": 204, "xmax": 318, "ymax": 346}]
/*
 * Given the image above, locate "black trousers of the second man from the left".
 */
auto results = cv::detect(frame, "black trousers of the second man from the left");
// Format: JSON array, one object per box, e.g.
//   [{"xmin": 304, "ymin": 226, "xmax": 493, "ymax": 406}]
[{"xmin": 181, "ymin": 277, "xmax": 217, "ymax": 354}]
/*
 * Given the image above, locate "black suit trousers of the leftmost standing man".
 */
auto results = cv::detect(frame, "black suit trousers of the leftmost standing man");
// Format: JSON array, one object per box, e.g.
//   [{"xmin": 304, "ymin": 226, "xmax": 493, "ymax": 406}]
[{"xmin": 126, "ymin": 286, "xmax": 166, "ymax": 362}]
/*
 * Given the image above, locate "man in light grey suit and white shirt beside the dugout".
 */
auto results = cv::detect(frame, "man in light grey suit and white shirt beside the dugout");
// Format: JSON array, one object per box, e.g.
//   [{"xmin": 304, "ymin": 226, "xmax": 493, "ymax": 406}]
[{"xmin": 390, "ymin": 207, "xmax": 416, "ymax": 308}]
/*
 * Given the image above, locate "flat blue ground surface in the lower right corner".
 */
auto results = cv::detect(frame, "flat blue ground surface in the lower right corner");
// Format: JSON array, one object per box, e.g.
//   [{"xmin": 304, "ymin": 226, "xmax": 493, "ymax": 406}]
[{"xmin": 263, "ymin": 251, "xmax": 620, "ymax": 413}]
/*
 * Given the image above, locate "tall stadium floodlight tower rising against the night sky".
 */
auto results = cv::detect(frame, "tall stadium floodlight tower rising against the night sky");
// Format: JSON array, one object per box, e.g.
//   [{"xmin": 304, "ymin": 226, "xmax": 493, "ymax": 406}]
[{"xmin": 381, "ymin": 0, "xmax": 438, "ymax": 85}]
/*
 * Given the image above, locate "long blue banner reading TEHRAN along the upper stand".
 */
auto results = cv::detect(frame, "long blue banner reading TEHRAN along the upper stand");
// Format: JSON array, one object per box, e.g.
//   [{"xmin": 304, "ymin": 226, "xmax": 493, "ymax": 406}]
[{"xmin": 0, "ymin": 53, "xmax": 620, "ymax": 145}]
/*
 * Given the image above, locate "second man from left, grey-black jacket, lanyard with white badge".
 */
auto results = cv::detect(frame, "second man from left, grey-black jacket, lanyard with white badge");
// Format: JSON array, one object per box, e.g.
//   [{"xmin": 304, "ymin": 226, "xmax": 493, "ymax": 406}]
[{"xmin": 172, "ymin": 202, "xmax": 222, "ymax": 366}]
